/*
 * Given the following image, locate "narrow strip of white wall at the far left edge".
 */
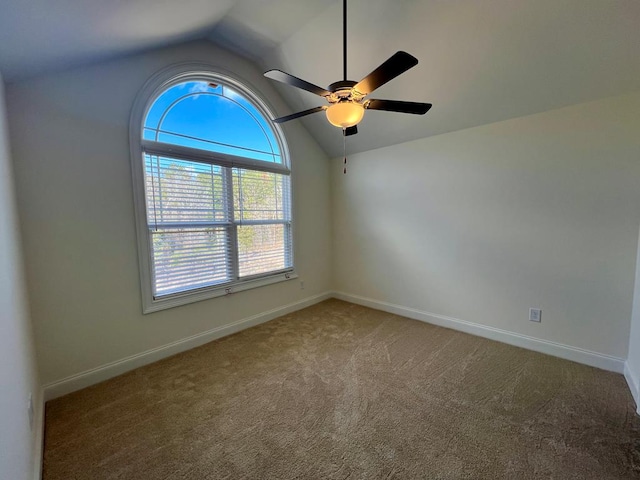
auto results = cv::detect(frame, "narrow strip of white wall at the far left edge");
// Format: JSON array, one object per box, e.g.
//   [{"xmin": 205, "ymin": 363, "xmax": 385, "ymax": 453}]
[{"xmin": 0, "ymin": 70, "xmax": 42, "ymax": 480}]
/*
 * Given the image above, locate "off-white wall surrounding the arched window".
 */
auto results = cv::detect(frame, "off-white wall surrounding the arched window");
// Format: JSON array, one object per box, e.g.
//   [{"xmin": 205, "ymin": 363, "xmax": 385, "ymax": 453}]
[{"xmin": 7, "ymin": 42, "xmax": 330, "ymax": 392}]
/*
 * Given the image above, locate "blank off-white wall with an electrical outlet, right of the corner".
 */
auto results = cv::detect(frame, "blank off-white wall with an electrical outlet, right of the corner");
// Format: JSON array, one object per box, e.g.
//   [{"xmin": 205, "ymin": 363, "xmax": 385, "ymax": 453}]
[{"xmin": 332, "ymin": 93, "xmax": 640, "ymax": 364}]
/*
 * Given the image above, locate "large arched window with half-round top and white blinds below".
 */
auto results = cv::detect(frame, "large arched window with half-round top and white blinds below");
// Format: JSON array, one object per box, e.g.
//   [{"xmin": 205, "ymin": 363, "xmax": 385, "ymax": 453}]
[{"xmin": 131, "ymin": 71, "xmax": 293, "ymax": 312}]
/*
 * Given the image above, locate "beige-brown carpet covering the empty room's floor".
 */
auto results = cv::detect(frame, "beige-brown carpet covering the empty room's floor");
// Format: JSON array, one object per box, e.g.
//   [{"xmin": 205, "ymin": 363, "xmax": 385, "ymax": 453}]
[{"xmin": 44, "ymin": 300, "xmax": 640, "ymax": 480}]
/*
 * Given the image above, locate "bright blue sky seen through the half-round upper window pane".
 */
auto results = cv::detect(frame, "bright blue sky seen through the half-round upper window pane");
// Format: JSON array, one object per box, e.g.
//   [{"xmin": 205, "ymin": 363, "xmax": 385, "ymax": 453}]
[{"xmin": 143, "ymin": 80, "xmax": 282, "ymax": 163}]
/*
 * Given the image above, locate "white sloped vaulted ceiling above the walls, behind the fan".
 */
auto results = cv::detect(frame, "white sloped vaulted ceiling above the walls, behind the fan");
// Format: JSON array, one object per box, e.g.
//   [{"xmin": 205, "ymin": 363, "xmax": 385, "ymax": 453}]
[{"xmin": 0, "ymin": 0, "xmax": 640, "ymax": 157}]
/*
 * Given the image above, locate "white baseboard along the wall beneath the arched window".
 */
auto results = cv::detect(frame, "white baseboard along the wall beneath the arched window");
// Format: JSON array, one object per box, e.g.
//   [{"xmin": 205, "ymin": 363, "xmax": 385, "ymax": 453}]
[{"xmin": 43, "ymin": 292, "xmax": 332, "ymax": 402}]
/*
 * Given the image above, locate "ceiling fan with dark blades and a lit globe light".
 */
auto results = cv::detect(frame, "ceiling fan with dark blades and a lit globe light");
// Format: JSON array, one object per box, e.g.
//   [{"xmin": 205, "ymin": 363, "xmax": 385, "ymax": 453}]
[{"xmin": 264, "ymin": 0, "xmax": 432, "ymax": 136}]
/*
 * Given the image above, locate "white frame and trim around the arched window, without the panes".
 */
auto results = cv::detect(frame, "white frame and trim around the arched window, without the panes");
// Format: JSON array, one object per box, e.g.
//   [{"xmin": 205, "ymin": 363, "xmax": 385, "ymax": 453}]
[{"xmin": 129, "ymin": 63, "xmax": 298, "ymax": 314}]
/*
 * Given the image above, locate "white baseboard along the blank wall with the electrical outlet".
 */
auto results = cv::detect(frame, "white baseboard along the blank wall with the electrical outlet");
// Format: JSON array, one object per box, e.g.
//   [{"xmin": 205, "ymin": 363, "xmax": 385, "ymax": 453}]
[{"xmin": 333, "ymin": 292, "xmax": 625, "ymax": 373}]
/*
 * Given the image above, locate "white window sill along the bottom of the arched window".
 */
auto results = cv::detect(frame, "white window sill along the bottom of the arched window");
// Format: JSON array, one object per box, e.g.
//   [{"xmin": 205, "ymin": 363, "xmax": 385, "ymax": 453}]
[{"xmin": 142, "ymin": 271, "xmax": 298, "ymax": 314}]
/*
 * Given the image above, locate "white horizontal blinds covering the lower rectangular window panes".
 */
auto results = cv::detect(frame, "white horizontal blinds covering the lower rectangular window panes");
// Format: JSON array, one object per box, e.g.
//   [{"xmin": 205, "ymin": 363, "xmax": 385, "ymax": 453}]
[{"xmin": 144, "ymin": 154, "xmax": 292, "ymax": 298}]
